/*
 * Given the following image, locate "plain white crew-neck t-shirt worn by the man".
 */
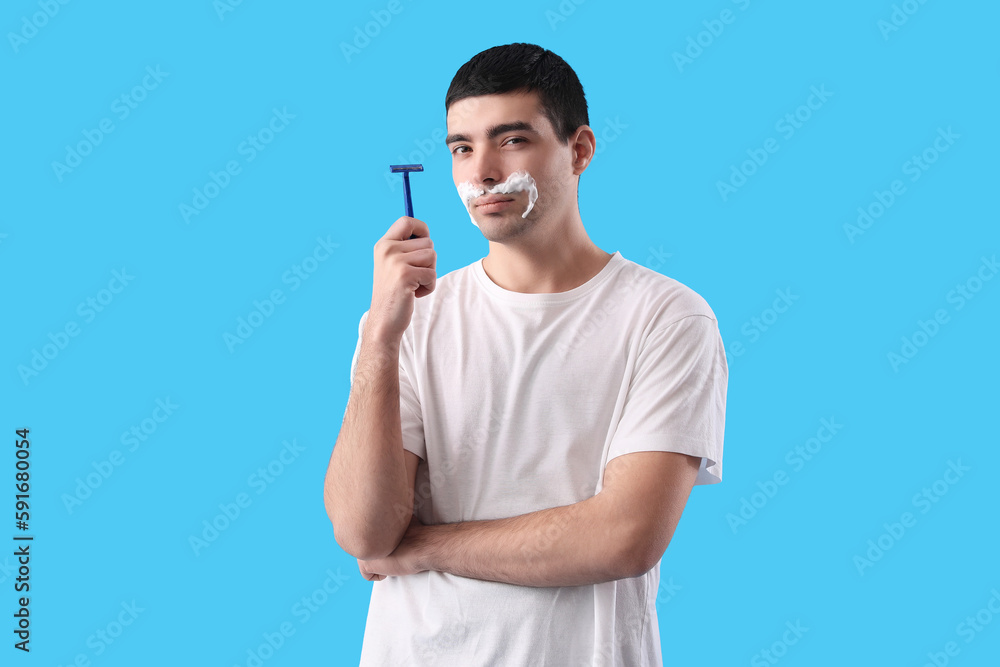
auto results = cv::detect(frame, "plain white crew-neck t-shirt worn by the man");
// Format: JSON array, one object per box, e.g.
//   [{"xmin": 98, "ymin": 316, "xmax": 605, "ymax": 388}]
[{"xmin": 351, "ymin": 252, "xmax": 728, "ymax": 667}]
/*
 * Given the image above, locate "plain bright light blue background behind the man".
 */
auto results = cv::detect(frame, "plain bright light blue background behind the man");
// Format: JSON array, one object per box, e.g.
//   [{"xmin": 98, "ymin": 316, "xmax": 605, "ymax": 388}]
[{"xmin": 0, "ymin": 0, "xmax": 1000, "ymax": 667}]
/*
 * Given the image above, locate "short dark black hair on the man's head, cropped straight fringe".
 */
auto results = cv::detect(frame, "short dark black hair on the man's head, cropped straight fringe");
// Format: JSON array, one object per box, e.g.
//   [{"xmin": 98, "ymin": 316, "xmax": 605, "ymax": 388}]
[{"xmin": 444, "ymin": 43, "xmax": 590, "ymax": 143}]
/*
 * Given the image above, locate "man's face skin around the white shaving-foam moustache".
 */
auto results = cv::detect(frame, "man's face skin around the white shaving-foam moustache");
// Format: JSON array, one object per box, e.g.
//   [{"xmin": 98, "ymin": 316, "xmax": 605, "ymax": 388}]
[{"xmin": 446, "ymin": 91, "xmax": 586, "ymax": 242}]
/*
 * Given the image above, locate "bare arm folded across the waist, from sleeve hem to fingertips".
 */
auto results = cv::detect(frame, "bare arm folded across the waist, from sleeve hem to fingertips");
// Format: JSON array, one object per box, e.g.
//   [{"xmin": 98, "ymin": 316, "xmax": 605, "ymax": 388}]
[{"xmin": 358, "ymin": 452, "xmax": 701, "ymax": 586}]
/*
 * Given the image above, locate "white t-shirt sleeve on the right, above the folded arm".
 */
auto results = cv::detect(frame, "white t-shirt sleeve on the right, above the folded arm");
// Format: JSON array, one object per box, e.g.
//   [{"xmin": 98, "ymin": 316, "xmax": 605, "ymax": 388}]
[{"xmin": 608, "ymin": 315, "xmax": 729, "ymax": 484}]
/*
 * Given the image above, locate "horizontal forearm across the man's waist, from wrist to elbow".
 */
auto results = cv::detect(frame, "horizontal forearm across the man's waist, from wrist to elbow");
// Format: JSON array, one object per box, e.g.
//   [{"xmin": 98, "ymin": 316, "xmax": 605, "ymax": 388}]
[{"xmin": 417, "ymin": 495, "xmax": 638, "ymax": 586}]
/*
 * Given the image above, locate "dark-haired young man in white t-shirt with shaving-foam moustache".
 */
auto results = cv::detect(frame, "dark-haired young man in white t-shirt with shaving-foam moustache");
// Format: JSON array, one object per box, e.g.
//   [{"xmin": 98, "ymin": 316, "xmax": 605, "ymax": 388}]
[{"xmin": 325, "ymin": 44, "xmax": 728, "ymax": 667}]
